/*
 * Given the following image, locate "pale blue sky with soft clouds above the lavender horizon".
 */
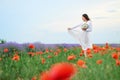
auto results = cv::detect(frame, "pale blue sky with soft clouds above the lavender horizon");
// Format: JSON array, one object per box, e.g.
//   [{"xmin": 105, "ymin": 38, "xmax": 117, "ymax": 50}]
[{"xmin": 0, "ymin": 0, "xmax": 120, "ymax": 44}]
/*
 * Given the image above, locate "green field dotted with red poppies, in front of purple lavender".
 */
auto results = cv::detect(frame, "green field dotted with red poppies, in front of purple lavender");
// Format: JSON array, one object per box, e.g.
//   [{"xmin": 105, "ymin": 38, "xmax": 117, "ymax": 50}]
[{"xmin": 0, "ymin": 43, "xmax": 120, "ymax": 80}]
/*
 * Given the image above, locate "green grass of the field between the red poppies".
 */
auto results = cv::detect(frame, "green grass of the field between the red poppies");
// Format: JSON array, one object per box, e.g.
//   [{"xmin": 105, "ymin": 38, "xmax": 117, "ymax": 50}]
[{"xmin": 0, "ymin": 47, "xmax": 120, "ymax": 80}]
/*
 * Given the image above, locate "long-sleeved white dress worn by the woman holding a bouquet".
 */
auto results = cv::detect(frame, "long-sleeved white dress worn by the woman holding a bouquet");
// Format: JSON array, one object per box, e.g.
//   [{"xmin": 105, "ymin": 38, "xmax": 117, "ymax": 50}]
[{"xmin": 68, "ymin": 21, "xmax": 92, "ymax": 50}]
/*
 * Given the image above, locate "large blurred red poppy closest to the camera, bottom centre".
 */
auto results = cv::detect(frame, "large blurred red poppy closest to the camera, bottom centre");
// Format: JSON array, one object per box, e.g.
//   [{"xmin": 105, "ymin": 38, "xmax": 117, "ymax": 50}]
[{"xmin": 49, "ymin": 63, "xmax": 75, "ymax": 80}]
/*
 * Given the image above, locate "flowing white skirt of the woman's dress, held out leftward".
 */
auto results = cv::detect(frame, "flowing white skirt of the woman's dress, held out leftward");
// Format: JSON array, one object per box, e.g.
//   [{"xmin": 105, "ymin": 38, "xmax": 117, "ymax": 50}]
[{"xmin": 68, "ymin": 29, "xmax": 92, "ymax": 50}]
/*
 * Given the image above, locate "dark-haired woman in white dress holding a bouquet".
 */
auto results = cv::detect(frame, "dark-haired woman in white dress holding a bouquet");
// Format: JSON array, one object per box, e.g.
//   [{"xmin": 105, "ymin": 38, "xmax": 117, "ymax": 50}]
[{"xmin": 68, "ymin": 14, "xmax": 92, "ymax": 57}]
